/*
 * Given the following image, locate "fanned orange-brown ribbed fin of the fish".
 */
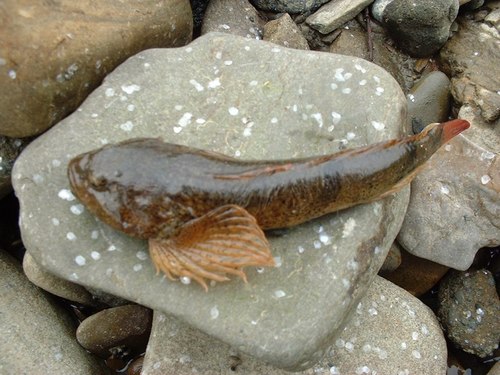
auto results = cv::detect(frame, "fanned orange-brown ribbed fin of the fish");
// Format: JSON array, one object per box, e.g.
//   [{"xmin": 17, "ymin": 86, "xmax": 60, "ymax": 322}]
[{"xmin": 149, "ymin": 205, "xmax": 275, "ymax": 291}]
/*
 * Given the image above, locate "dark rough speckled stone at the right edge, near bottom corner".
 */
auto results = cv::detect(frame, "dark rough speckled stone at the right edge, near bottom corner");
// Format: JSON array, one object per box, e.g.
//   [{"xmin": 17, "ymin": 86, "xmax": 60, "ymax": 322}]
[{"xmin": 438, "ymin": 270, "xmax": 500, "ymax": 357}]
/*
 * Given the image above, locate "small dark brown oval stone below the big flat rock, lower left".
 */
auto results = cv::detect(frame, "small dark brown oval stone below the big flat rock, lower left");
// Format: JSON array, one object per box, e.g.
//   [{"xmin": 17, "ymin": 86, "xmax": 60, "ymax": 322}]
[{"xmin": 76, "ymin": 305, "xmax": 153, "ymax": 358}]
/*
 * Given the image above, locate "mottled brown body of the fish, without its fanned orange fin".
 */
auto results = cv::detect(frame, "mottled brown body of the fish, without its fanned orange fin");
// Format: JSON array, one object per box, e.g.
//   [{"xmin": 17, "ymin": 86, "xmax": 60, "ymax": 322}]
[{"xmin": 68, "ymin": 120, "xmax": 469, "ymax": 287}]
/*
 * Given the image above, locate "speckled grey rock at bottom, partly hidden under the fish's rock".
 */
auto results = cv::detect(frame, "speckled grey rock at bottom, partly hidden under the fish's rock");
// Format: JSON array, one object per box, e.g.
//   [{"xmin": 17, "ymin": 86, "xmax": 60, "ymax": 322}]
[{"xmin": 142, "ymin": 277, "xmax": 447, "ymax": 375}]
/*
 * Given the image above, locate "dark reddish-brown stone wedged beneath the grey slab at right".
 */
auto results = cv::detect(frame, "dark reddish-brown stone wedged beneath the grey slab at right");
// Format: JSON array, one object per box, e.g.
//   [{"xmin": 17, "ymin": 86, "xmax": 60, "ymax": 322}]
[{"xmin": 381, "ymin": 249, "xmax": 448, "ymax": 297}]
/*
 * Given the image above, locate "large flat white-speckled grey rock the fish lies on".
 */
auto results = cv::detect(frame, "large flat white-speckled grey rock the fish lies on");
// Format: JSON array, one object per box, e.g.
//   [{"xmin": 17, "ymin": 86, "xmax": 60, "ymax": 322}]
[{"xmin": 13, "ymin": 33, "xmax": 408, "ymax": 370}]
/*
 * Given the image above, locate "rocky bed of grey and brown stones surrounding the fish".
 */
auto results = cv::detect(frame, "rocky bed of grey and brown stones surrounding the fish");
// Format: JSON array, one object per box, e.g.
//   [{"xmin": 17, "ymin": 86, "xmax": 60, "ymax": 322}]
[{"xmin": 0, "ymin": 0, "xmax": 500, "ymax": 375}]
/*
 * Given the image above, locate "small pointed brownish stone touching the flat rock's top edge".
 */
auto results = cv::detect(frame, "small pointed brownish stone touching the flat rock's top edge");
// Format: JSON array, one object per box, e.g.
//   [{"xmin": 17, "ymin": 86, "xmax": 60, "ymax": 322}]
[{"xmin": 264, "ymin": 13, "xmax": 309, "ymax": 50}]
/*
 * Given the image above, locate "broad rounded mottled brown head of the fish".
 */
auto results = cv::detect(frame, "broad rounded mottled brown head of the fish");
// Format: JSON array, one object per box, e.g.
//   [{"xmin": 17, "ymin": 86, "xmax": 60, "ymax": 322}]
[{"xmin": 68, "ymin": 138, "xmax": 193, "ymax": 238}]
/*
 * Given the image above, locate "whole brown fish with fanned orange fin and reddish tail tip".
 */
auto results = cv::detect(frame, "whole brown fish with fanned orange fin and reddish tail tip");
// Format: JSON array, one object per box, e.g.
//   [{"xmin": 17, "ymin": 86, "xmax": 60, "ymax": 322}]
[{"xmin": 68, "ymin": 119, "xmax": 470, "ymax": 291}]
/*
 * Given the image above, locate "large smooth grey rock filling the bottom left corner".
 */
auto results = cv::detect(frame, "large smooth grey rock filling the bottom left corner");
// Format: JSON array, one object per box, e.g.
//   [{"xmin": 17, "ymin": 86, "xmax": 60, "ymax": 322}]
[{"xmin": 0, "ymin": 249, "xmax": 104, "ymax": 375}]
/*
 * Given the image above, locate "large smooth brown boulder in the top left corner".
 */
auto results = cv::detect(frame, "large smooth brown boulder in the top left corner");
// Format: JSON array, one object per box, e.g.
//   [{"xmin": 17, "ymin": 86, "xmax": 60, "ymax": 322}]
[{"xmin": 0, "ymin": 0, "xmax": 192, "ymax": 137}]
